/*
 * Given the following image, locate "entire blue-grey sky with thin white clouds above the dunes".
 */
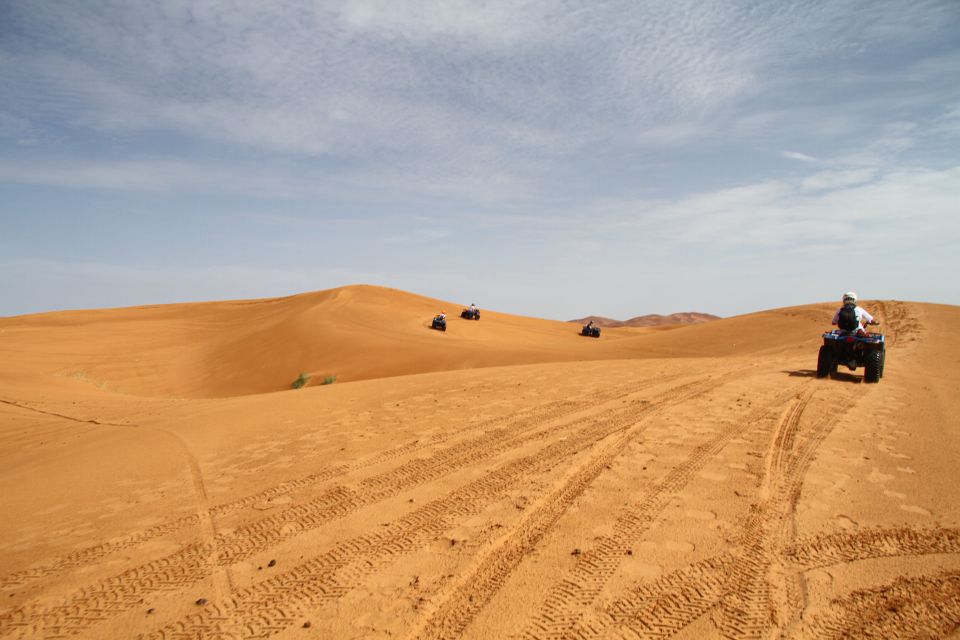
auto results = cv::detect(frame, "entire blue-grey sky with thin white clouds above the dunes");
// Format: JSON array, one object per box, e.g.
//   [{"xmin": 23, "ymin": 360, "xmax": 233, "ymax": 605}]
[{"xmin": 0, "ymin": 0, "xmax": 960, "ymax": 320}]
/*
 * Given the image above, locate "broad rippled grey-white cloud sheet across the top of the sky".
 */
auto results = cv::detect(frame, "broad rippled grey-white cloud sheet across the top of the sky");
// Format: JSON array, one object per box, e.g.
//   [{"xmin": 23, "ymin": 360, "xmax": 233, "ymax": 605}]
[{"xmin": 2, "ymin": 0, "xmax": 942, "ymax": 163}]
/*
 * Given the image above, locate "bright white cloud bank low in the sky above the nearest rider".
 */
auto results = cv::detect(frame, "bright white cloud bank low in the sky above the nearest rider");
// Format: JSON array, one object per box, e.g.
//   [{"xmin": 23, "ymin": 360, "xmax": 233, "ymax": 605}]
[{"xmin": 524, "ymin": 166, "xmax": 960, "ymax": 258}]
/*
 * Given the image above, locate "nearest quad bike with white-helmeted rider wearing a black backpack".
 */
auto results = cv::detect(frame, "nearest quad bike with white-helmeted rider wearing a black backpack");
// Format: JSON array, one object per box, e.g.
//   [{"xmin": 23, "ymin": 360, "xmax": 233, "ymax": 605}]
[{"xmin": 817, "ymin": 291, "xmax": 887, "ymax": 382}]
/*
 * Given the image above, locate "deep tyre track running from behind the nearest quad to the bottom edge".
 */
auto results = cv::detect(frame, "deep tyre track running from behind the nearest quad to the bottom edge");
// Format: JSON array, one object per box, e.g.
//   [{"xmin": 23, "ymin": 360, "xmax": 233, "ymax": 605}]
[{"xmin": 561, "ymin": 376, "xmax": 868, "ymax": 638}]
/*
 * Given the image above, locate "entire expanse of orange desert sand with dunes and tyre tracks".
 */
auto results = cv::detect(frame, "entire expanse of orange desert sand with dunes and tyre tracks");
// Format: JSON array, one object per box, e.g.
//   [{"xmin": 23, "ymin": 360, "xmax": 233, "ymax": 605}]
[{"xmin": 0, "ymin": 286, "xmax": 960, "ymax": 640}]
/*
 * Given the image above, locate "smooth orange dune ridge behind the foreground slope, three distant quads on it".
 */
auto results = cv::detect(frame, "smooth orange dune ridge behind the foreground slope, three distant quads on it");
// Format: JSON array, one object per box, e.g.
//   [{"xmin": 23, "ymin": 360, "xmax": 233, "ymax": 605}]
[{"xmin": 0, "ymin": 285, "xmax": 829, "ymax": 398}]
